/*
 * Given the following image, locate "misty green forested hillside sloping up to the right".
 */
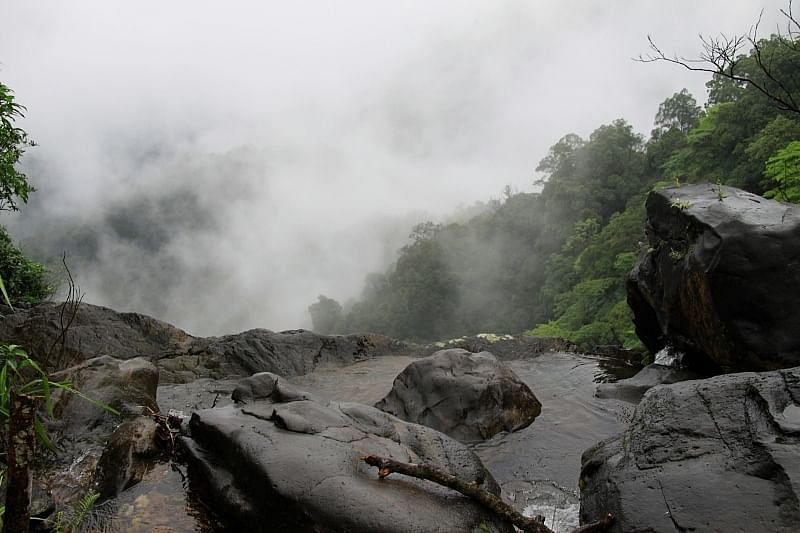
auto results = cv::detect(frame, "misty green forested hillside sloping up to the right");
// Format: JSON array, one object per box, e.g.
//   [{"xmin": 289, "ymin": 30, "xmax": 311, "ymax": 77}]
[{"xmin": 309, "ymin": 35, "xmax": 800, "ymax": 348}]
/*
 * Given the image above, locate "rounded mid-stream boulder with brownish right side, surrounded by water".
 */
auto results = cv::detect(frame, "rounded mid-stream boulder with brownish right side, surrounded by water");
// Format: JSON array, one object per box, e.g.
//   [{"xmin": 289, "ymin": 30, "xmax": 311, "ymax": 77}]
[{"xmin": 375, "ymin": 348, "xmax": 542, "ymax": 442}]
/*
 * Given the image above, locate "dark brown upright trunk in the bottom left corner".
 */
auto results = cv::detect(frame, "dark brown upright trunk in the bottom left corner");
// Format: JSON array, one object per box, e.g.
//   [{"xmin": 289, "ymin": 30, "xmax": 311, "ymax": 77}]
[{"xmin": 3, "ymin": 392, "xmax": 36, "ymax": 533}]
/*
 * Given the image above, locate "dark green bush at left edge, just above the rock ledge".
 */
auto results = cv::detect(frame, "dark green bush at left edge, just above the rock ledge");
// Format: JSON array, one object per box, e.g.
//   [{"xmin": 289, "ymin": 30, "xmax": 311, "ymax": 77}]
[{"xmin": 0, "ymin": 226, "xmax": 53, "ymax": 305}]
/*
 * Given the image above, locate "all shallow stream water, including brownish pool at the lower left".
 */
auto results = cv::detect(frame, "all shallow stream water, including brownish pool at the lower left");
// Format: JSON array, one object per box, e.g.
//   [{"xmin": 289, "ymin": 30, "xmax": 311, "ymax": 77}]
[{"xmin": 106, "ymin": 353, "xmax": 631, "ymax": 532}]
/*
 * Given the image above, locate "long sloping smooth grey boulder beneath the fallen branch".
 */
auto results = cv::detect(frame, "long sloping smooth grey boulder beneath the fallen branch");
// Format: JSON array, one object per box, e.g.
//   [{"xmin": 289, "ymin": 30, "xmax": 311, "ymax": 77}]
[{"xmin": 182, "ymin": 373, "xmax": 513, "ymax": 533}]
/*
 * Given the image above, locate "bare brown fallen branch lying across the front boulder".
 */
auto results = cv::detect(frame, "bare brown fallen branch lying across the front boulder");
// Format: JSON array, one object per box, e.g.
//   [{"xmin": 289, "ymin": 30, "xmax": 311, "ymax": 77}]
[{"xmin": 363, "ymin": 455, "xmax": 614, "ymax": 533}]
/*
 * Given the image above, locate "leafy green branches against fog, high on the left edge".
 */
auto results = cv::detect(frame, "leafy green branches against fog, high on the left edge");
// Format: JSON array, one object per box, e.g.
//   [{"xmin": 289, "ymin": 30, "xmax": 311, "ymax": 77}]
[{"xmin": 0, "ymin": 83, "xmax": 34, "ymax": 211}]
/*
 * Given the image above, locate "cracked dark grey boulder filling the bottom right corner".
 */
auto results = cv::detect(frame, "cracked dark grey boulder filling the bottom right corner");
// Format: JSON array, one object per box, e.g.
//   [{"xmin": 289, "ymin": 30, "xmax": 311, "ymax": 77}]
[{"xmin": 580, "ymin": 368, "xmax": 800, "ymax": 533}]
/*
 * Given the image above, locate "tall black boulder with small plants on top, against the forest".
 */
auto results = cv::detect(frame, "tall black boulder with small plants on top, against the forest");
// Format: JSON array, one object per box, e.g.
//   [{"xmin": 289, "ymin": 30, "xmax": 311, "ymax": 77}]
[{"xmin": 628, "ymin": 184, "xmax": 800, "ymax": 372}]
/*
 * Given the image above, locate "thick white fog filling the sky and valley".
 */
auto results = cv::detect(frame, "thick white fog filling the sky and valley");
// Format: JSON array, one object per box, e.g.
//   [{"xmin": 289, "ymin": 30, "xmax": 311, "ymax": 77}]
[{"xmin": 0, "ymin": 0, "xmax": 785, "ymax": 335}]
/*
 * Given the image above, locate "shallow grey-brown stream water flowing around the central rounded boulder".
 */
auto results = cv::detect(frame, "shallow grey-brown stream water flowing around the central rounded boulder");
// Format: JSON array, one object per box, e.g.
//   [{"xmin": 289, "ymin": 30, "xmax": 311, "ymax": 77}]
[{"xmin": 291, "ymin": 353, "xmax": 631, "ymax": 531}]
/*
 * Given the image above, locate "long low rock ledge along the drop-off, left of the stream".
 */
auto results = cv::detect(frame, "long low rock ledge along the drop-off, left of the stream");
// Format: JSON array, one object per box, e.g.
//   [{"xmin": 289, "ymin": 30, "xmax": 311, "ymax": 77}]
[{"xmin": 0, "ymin": 303, "xmax": 410, "ymax": 383}]
